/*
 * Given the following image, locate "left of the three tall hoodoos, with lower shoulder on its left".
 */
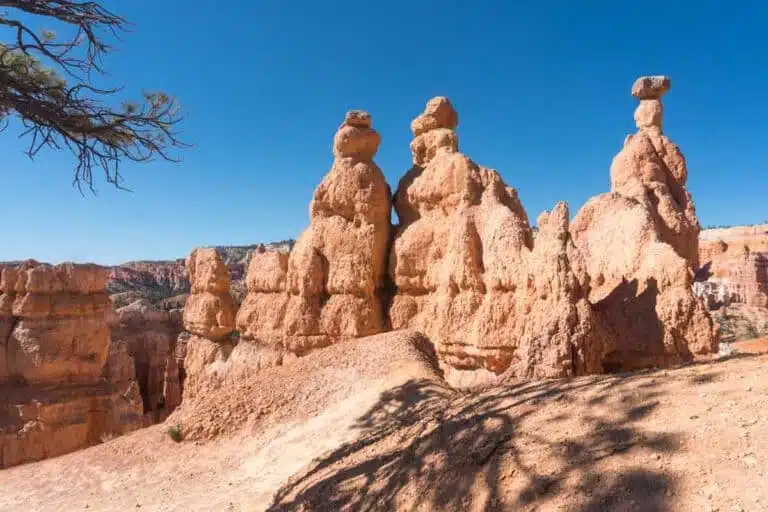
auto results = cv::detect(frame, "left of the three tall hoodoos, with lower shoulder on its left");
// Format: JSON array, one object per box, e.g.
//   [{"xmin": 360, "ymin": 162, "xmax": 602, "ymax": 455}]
[{"xmin": 237, "ymin": 111, "xmax": 391, "ymax": 355}]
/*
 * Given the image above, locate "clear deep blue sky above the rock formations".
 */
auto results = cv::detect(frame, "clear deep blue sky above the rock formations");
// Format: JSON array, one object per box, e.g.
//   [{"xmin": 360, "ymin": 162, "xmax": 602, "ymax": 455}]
[{"xmin": 0, "ymin": 0, "xmax": 768, "ymax": 264}]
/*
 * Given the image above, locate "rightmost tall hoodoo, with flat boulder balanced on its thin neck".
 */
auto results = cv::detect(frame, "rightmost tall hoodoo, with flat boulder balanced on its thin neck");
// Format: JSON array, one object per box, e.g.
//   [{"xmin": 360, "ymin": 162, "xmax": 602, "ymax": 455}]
[{"xmin": 571, "ymin": 77, "xmax": 717, "ymax": 370}]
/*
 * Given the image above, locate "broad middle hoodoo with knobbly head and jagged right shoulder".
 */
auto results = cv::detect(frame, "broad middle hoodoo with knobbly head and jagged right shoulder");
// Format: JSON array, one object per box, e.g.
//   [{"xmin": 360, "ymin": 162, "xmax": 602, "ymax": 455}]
[{"xmin": 389, "ymin": 97, "xmax": 605, "ymax": 380}]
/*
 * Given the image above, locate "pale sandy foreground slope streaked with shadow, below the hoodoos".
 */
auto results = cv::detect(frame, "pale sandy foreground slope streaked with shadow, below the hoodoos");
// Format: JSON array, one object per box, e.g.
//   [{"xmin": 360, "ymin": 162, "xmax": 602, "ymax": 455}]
[{"xmin": 0, "ymin": 348, "xmax": 768, "ymax": 511}]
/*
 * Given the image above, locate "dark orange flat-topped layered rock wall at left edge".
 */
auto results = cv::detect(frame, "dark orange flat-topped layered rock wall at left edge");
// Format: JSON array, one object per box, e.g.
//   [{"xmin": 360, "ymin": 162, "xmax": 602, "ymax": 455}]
[{"xmin": 0, "ymin": 261, "xmax": 141, "ymax": 467}]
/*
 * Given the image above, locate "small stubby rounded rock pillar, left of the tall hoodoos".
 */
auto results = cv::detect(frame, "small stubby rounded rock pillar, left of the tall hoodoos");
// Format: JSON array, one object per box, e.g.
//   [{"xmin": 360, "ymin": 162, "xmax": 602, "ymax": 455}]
[{"xmin": 183, "ymin": 248, "xmax": 235, "ymax": 340}]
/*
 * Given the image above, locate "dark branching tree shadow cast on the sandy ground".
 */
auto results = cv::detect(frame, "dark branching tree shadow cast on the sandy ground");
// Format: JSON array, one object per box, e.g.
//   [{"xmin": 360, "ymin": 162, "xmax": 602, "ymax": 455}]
[{"xmin": 269, "ymin": 375, "xmax": 679, "ymax": 512}]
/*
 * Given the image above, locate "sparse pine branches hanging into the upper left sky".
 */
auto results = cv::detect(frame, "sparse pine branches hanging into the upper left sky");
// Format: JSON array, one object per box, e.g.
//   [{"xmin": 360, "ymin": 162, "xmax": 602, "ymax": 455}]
[{"xmin": 0, "ymin": 0, "xmax": 186, "ymax": 191}]
